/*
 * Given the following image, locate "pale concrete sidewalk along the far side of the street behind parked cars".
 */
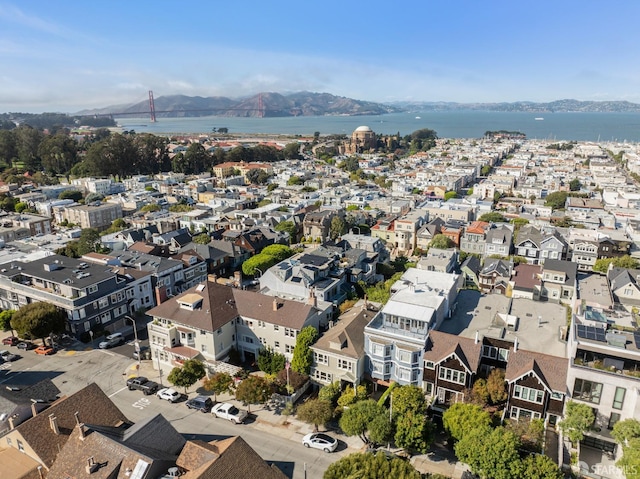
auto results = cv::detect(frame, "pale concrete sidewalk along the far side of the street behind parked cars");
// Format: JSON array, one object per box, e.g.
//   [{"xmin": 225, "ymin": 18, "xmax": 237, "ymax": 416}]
[{"xmin": 130, "ymin": 360, "xmax": 364, "ymax": 453}]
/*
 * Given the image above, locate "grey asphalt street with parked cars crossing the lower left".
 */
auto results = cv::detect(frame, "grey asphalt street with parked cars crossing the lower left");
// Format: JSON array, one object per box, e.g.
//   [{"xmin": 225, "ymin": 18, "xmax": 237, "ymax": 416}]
[{"xmin": 0, "ymin": 344, "xmax": 342, "ymax": 479}]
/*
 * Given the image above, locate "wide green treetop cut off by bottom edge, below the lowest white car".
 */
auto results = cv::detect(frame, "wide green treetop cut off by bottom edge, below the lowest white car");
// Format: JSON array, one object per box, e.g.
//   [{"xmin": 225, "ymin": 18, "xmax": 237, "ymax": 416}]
[{"xmin": 322, "ymin": 452, "xmax": 422, "ymax": 479}]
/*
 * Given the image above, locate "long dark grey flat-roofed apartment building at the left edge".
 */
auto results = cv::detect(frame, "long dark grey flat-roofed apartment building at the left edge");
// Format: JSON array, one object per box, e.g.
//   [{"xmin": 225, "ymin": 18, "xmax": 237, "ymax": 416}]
[{"xmin": 0, "ymin": 255, "xmax": 146, "ymax": 337}]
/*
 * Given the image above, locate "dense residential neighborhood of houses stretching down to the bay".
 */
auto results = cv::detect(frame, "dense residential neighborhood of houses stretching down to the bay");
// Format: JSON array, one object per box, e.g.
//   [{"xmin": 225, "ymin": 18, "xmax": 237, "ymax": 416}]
[{"xmin": 0, "ymin": 126, "xmax": 640, "ymax": 479}]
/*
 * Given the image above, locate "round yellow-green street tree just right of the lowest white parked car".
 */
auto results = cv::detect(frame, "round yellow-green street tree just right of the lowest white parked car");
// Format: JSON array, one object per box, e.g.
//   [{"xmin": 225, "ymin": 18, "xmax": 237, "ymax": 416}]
[{"xmin": 339, "ymin": 399, "xmax": 391, "ymax": 444}]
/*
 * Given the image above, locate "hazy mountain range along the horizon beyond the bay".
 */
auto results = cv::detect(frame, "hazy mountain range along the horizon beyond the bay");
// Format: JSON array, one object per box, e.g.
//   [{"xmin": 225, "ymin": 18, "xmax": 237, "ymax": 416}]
[{"xmin": 77, "ymin": 92, "xmax": 640, "ymax": 118}]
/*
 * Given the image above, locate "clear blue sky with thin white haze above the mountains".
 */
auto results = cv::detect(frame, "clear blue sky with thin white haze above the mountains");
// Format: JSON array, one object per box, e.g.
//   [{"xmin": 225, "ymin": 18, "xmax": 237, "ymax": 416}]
[{"xmin": 0, "ymin": 0, "xmax": 640, "ymax": 112}]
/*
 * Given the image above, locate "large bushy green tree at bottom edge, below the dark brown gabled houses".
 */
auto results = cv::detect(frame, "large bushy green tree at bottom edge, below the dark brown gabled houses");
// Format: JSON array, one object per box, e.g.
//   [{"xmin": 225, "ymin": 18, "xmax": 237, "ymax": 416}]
[{"xmin": 455, "ymin": 427, "xmax": 521, "ymax": 479}]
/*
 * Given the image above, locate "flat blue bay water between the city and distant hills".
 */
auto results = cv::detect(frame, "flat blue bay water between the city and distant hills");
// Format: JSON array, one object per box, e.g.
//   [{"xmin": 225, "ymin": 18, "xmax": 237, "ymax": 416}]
[{"xmin": 116, "ymin": 111, "xmax": 640, "ymax": 143}]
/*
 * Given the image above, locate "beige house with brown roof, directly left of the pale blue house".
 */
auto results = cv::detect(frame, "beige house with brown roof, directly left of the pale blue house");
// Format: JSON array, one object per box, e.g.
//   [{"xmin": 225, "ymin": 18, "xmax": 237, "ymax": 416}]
[{"xmin": 311, "ymin": 301, "xmax": 378, "ymax": 386}]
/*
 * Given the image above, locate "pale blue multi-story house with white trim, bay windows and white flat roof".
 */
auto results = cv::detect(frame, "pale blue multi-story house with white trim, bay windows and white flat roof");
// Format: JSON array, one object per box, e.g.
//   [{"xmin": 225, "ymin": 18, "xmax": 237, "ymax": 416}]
[{"xmin": 364, "ymin": 268, "xmax": 462, "ymax": 385}]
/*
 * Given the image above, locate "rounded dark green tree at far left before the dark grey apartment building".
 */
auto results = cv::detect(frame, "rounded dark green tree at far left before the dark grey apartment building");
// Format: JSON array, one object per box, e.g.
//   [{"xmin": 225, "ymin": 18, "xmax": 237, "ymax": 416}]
[{"xmin": 10, "ymin": 302, "xmax": 67, "ymax": 342}]
